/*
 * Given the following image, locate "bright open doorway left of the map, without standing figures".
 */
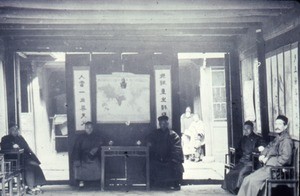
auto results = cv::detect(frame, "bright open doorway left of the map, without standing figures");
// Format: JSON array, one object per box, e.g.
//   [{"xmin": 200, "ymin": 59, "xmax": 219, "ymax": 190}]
[{"xmin": 15, "ymin": 52, "xmax": 69, "ymax": 181}]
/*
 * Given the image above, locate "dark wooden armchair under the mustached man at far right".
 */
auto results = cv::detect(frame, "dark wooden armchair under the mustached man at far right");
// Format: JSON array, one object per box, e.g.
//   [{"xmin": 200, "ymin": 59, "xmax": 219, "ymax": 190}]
[{"xmin": 266, "ymin": 148, "xmax": 299, "ymax": 196}]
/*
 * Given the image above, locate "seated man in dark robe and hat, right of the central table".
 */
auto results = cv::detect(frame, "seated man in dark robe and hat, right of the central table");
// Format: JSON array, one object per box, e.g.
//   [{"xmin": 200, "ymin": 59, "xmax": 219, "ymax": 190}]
[{"xmin": 147, "ymin": 116, "xmax": 184, "ymax": 190}]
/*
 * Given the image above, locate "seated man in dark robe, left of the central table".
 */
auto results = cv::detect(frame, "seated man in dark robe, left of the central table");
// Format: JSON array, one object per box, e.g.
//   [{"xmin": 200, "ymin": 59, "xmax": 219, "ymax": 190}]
[{"xmin": 72, "ymin": 122, "xmax": 102, "ymax": 187}]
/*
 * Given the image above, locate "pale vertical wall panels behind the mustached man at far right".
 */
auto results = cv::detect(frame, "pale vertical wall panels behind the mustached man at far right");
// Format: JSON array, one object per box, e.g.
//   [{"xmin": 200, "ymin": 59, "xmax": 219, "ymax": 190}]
[{"xmin": 266, "ymin": 42, "xmax": 300, "ymax": 140}]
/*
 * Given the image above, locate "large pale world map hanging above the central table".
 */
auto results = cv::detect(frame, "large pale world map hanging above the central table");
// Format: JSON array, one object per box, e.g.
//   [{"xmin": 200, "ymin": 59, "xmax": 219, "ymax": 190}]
[{"xmin": 96, "ymin": 72, "xmax": 150, "ymax": 123}]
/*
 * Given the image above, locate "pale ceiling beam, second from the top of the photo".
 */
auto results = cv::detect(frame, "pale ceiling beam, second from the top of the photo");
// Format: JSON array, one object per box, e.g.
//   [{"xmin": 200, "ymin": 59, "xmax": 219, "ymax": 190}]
[{"xmin": 0, "ymin": 9, "xmax": 287, "ymax": 20}]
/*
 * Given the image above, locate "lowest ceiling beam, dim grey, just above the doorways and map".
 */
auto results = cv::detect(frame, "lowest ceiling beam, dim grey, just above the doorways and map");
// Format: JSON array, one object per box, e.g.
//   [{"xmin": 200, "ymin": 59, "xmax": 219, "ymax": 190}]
[{"xmin": 8, "ymin": 39, "xmax": 234, "ymax": 52}]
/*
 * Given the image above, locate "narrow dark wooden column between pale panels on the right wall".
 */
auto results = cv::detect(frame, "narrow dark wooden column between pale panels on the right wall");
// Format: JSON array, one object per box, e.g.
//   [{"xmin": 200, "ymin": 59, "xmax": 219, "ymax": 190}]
[{"xmin": 256, "ymin": 29, "xmax": 269, "ymax": 139}]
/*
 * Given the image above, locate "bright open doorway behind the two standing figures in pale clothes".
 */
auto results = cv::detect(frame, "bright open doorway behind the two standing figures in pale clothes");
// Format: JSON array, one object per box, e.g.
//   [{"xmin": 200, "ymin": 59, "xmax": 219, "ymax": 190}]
[{"xmin": 178, "ymin": 53, "xmax": 228, "ymax": 181}]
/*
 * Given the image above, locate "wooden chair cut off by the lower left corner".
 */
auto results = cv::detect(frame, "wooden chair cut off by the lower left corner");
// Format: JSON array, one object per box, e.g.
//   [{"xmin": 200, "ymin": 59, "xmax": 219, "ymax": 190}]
[{"xmin": 0, "ymin": 154, "xmax": 13, "ymax": 196}]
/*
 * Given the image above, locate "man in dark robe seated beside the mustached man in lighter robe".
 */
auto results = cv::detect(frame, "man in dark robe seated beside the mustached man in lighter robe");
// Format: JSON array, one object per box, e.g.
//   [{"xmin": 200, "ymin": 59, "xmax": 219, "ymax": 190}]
[{"xmin": 222, "ymin": 121, "xmax": 265, "ymax": 194}]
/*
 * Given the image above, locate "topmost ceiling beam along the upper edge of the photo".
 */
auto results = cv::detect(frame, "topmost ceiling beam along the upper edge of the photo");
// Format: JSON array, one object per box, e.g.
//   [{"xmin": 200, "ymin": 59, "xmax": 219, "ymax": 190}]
[{"xmin": 0, "ymin": 0, "xmax": 296, "ymax": 10}]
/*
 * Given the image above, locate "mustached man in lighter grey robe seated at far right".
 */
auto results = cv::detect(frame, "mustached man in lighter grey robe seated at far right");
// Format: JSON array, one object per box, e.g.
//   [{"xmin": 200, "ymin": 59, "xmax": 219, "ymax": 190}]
[{"xmin": 238, "ymin": 115, "xmax": 293, "ymax": 196}]
